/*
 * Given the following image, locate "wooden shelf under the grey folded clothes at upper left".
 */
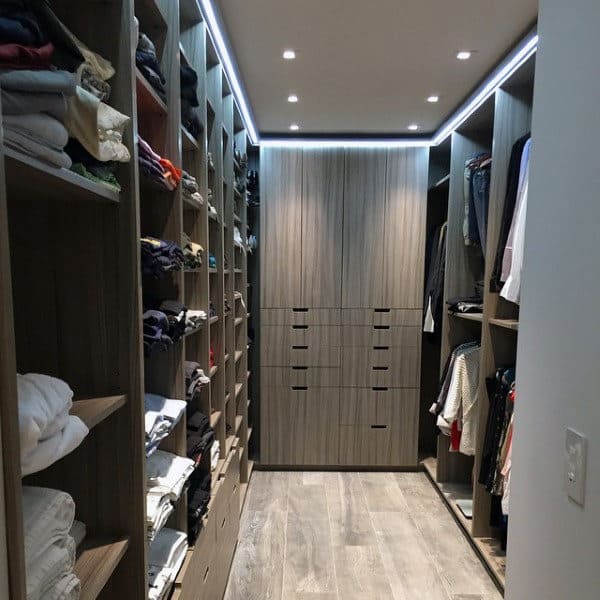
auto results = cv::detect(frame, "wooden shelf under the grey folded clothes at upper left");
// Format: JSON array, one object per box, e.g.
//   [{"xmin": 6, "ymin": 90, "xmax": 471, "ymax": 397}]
[{"xmin": 4, "ymin": 147, "xmax": 120, "ymax": 204}]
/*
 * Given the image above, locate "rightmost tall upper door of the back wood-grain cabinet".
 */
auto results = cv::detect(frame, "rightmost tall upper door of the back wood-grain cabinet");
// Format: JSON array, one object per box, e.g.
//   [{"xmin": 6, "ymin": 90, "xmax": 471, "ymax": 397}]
[{"xmin": 382, "ymin": 148, "xmax": 428, "ymax": 308}]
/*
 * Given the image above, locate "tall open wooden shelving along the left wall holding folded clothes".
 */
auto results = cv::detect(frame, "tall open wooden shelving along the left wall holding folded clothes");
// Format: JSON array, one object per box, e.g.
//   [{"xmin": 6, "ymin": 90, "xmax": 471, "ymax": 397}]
[{"xmin": 0, "ymin": 0, "xmax": 252, "ymax": 600}]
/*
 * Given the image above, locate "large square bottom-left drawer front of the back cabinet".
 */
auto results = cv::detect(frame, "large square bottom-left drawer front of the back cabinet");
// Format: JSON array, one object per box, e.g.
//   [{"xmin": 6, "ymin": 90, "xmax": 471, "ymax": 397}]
[{"xmin": 260, "ymin": 386, "xmax": 340, "ymax": 466}]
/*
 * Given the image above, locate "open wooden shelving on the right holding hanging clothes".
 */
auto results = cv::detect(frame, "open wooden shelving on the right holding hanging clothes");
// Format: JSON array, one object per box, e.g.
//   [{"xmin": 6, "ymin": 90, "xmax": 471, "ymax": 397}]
[{"xmin": 421, "ymin": 58, "xmax": 535, "ymax": 590}]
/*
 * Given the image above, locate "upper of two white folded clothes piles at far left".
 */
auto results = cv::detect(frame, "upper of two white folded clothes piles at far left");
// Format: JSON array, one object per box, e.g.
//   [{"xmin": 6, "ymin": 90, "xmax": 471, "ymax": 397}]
[{"xmin": 17, "ymin": 373, "xmax": 89, "ymax": 476}]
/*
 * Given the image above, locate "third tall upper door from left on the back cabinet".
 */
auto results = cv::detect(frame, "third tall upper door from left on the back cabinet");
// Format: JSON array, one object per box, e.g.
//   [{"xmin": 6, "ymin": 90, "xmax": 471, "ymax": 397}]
[{"xmin": 342, "ymin": 149, "xmax": 387, "ymax": 308}]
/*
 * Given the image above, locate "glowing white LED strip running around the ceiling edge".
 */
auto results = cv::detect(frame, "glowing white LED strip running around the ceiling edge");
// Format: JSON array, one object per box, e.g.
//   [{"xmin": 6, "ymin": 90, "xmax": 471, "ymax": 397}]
[{"xmin": 199, "ymin": 0, "xmax": 539, "ymax": 148}]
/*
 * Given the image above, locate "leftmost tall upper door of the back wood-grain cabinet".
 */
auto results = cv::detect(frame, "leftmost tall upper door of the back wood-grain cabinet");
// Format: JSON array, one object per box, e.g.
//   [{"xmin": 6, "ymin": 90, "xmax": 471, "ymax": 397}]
[{"xmin": 260, "ymin": 148, "xmax": 302, "ymax": 308}]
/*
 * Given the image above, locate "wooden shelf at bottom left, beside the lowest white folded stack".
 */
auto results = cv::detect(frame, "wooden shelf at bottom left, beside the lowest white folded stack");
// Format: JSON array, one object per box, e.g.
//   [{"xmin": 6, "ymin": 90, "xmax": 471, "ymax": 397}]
[{"xmin": 74, "ymin": 538, "xmax": 129, "ymax": 600}]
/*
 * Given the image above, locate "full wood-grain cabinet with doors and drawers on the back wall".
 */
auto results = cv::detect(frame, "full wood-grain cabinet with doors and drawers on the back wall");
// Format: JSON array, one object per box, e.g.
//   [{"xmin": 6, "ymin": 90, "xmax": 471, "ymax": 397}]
[{"xmin": 261, "ymin": 148, "xmax": 428, "ymax": 466}]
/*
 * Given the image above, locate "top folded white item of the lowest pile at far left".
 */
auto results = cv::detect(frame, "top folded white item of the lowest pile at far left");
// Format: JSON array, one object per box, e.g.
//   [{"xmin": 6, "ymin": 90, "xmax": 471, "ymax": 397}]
[{"xmin": 22, "ymin": 486, "xmax": 75, "ymax": 573}]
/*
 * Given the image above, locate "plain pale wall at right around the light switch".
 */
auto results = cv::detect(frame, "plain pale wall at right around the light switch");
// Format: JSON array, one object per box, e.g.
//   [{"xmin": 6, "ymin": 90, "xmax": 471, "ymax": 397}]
[{"xmin": 507, "ymin": 0, "xmax": 600, "ymax": 600}]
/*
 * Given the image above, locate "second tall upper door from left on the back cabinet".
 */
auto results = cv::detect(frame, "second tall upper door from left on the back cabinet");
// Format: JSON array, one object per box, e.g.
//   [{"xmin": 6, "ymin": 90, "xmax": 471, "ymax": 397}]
[{"xmin": 296, "ymin": 149, "xmax": 344, "ymax": 308}]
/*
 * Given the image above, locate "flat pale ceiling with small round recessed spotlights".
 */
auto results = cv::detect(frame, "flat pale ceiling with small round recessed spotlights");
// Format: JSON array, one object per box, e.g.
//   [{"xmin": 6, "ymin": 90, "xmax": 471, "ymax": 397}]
[{"xmin": 216, "ymin": 0, "xmax": 537, "ymax": 135}]
